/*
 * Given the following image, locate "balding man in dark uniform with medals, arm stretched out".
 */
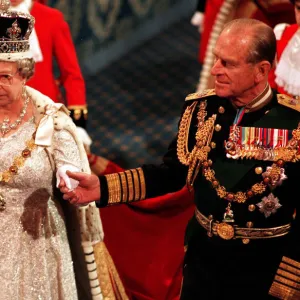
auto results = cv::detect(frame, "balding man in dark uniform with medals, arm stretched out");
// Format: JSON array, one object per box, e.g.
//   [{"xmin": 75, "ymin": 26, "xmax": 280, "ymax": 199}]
[{"xmin": 61, "ymin": 19, "xmax": 300, "ymax": 300}]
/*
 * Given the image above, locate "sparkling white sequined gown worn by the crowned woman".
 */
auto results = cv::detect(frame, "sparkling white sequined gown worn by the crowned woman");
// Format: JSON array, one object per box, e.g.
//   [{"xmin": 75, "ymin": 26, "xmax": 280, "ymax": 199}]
[{"xmin": 0, "ymin": 120, "xmax": 81, "ymax": 300}]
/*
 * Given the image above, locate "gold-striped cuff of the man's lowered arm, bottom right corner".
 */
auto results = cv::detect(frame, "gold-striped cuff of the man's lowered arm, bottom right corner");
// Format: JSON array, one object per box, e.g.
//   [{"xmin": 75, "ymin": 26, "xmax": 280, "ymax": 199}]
[{"xmin": 269, "ymin": 256, "xmax": 300, "ymax": 300}]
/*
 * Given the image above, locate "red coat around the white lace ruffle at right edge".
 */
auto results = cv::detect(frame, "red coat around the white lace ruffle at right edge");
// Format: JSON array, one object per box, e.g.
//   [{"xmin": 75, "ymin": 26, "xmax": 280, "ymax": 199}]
[{"xmin": 269, "ymin": 24, "xmax": 299, "ymax": 94}]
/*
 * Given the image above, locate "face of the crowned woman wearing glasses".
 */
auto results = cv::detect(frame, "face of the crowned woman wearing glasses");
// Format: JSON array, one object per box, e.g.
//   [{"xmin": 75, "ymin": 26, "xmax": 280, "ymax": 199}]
[{"xmin": 0, "ymin": 61, "xmax": 25, "ymax": 107}]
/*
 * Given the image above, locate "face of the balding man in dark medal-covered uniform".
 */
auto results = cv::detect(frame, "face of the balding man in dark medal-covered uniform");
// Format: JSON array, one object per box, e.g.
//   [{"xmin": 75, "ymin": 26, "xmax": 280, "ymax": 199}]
[{"xmin": 211, "ymin": 29, "xmax": 255, "ymax": 105}]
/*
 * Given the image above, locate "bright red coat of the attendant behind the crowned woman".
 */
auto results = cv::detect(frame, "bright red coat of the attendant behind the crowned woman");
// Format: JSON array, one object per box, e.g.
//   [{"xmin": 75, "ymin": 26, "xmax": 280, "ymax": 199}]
[{"xmin": 27, "ymin": 2, "xmax": 86, "ymax": 108}]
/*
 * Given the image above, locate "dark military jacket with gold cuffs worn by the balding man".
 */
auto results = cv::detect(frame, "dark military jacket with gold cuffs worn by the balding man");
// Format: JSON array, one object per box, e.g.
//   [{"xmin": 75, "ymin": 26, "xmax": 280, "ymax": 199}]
[{"xmin": 97, "ymin": 91, "xmax": 300, "ymax": 299}]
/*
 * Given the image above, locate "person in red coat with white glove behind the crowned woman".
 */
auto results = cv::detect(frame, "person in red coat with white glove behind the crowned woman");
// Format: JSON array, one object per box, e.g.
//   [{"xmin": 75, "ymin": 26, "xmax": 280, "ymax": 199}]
[{"xmin": 10, "ymin": 0, "xmax": 119, "ymax": 174}]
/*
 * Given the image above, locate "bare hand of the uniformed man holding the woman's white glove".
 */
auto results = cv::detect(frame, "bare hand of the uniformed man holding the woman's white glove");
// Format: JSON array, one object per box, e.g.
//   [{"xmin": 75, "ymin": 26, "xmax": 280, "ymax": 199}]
[{"xmin": 59, "ymin": 171, "xmax": 100, "ymax": 206}]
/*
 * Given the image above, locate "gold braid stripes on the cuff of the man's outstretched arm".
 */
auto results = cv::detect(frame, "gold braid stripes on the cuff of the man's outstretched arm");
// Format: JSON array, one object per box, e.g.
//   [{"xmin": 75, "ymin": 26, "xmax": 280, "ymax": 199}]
[{"xmin": 105, "ymin": 168, "xmax": 146, "ymax": 205}]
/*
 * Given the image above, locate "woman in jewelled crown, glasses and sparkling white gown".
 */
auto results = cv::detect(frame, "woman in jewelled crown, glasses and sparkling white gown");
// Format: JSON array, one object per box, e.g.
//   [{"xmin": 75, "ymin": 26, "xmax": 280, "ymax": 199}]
[{"xmin": 0, "ymin": 0, "xmax": 126, "ymax": 300}]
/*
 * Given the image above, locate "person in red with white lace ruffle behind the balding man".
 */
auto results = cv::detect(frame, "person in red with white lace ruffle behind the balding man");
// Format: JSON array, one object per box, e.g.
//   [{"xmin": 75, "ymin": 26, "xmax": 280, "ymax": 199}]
[{"xmin": 269, "ymin": 0, "xmax": 300, "ymax": 96}]
